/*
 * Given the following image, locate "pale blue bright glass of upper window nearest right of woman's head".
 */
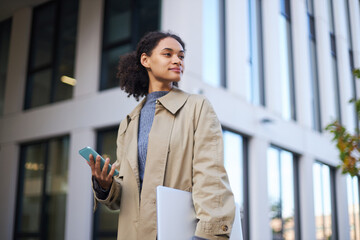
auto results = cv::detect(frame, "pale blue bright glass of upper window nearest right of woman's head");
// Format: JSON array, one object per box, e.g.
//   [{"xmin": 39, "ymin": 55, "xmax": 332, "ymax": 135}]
[{"xmin": 202, "ymin": 0, "xmax": 221, "ymax": 87}]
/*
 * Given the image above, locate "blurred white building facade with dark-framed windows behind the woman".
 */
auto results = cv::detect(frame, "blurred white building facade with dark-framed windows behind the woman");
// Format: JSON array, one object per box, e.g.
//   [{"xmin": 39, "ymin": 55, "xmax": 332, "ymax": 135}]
[{"xmin": 0, "ymin": 0, "xmax": 360, "ymax": 240}]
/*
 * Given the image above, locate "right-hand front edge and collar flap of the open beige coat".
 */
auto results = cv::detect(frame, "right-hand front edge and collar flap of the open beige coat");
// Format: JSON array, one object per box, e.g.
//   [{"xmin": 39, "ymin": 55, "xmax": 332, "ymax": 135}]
[{"xmin": 138, "ymin": 88, "xmax": 188, "ymax": 239}]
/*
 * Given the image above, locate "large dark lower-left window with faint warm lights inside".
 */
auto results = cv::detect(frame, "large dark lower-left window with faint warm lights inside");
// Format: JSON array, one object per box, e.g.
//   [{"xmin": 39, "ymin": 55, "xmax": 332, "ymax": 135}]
[{"xmin": 14, "ymin": 136, "xmax": 69, "ymax": 240}]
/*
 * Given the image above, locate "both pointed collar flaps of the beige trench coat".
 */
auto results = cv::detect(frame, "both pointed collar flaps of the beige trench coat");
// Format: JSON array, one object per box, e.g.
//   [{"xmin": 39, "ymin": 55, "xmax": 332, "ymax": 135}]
[{"xmin": 128, "ymin": 87, "xmax": 189, "ymax": 120}]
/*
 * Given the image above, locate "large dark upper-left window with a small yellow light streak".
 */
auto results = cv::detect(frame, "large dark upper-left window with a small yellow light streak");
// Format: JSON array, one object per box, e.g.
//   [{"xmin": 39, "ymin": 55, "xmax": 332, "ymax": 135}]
[{"xmin": 25, "ymin": 0, "xmax": 78, "ymax": 109}]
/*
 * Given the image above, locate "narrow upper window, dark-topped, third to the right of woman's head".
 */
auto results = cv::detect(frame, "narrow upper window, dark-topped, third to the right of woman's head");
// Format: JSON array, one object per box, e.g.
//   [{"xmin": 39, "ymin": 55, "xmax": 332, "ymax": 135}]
[{"xmin": 279, "ymin": 0, "xmax": 296, "ymax": 120}]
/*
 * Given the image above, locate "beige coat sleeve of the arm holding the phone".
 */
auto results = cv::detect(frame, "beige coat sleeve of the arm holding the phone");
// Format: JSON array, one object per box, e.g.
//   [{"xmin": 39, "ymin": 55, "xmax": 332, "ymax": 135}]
[{"xmin": 92, "ymin": 118, "xmax": 128, "ymax": 211}]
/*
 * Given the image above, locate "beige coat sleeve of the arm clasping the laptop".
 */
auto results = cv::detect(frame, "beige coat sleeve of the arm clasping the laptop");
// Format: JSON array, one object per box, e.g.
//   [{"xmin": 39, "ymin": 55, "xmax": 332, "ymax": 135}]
[{"xmin": 192, "ymin": 99, "xmax": 235, "ymax": 239}]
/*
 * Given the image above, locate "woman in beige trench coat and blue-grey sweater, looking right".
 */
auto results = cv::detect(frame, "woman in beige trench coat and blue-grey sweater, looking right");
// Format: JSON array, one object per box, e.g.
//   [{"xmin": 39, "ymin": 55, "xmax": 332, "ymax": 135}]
[{"xmin": 89, "ymin": 32, "xmax": 235, "ymax": 240}]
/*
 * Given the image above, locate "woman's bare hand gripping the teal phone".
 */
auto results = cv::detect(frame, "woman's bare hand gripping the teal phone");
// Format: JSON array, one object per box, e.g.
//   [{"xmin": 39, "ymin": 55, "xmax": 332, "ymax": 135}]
[{"xmin": 88, "ymin": 154, "xmax": 116, "ymax": 190}]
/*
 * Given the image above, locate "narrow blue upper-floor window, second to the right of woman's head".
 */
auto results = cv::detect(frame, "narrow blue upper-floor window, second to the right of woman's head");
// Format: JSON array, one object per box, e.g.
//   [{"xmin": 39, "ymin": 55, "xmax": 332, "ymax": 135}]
[{"xmin": 248, "ymin": 0, "xmax": 265, "ymax": 106}]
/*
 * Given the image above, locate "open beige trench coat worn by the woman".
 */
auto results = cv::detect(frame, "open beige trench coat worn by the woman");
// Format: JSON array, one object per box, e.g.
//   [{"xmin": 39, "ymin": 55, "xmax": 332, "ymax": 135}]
[{"xmin": 94, "ymin": 88, "xmax": 235, "ymax": 240}]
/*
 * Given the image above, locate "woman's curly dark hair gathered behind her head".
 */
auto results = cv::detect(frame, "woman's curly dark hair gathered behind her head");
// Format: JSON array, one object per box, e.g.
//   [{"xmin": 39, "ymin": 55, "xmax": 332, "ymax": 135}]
[{"xmin": 116, "ymin": 31, "xmax": 185, "ymax": 101}]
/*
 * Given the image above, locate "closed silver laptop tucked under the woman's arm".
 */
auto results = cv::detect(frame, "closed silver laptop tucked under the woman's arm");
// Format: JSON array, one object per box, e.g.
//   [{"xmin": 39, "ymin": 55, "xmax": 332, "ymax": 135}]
[{"xmin": 156, "ymin": 186, "xmax": 243, "ymax": 240}]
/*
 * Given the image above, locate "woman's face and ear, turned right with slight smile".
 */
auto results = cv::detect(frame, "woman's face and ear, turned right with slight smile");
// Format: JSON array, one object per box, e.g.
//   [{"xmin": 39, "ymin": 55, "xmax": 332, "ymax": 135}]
[{"xmin": 141, "ymin": 37, "xmax": 185, "ymax": 84}]
